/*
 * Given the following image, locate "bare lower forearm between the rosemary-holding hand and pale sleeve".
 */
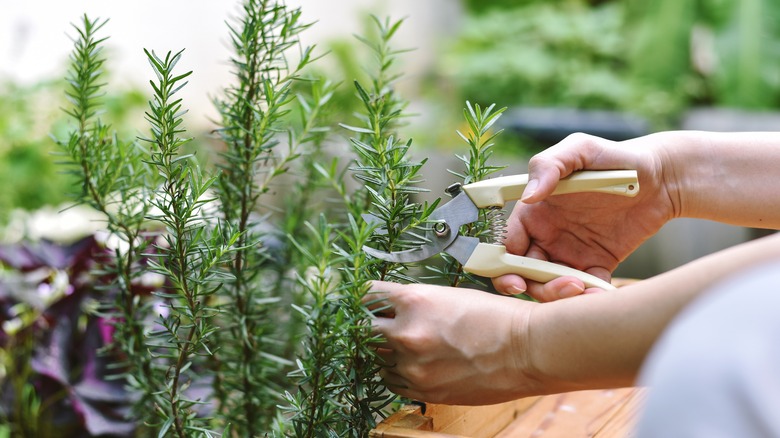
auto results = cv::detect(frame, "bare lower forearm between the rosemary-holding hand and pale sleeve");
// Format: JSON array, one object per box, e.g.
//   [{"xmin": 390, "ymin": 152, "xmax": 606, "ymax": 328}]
[{"xmin": 527, "ymin": 236, "xmax": 780, "ymax": 393}]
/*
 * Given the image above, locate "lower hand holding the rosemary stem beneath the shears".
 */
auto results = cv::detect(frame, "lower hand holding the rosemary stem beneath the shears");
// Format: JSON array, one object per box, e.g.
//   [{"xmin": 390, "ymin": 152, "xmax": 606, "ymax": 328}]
[{"xmin": 365, "ymin": 281, "xmax": 539, "ymax": 405}]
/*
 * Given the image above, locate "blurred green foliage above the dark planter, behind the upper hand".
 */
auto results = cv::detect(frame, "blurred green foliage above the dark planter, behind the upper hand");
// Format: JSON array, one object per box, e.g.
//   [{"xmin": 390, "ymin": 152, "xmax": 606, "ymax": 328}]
[{"xmin": 439, "ymin": 0, "xmax": 780, "ymax": 128}]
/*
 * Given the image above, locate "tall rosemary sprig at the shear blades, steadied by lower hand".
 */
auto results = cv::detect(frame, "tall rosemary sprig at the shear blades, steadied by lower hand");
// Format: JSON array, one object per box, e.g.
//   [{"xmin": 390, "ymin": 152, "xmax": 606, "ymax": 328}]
[{"xmin": 340, "ymin": 13, "xmax": 435, "ymax": 436}]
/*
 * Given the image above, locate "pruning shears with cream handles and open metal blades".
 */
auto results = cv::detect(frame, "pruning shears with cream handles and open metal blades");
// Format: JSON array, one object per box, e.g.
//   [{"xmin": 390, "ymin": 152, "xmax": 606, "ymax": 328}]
[{"xmin": 363, "ymin": 170, "xmax": 639, "ymax": 289}]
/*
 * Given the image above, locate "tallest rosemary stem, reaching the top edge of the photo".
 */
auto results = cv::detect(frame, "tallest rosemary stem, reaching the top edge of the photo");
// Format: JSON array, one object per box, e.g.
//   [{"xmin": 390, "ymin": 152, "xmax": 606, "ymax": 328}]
[{"xmin": 210, "ymin": 0, "xmax": 331, "ymax": 436}]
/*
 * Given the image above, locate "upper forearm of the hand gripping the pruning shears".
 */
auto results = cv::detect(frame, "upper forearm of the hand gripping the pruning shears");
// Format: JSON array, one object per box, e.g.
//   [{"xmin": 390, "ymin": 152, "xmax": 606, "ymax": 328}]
[{"xmin": 654, "ymin": 131, "xmax": 780, "ymax": 229}]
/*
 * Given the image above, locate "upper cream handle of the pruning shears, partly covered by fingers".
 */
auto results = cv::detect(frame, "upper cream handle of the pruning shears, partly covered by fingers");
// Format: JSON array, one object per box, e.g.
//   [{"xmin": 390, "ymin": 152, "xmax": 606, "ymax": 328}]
[{"xmin": 463, "ymin": 170, "xmax": 639, "ymax": 208}]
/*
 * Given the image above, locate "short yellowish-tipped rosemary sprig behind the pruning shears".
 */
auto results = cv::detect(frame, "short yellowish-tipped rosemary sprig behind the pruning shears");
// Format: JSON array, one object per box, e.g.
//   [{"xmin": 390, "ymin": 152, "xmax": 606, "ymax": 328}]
[{"xmin": 427, "ymin": 101, "xmax": 506, "ymax": 286}]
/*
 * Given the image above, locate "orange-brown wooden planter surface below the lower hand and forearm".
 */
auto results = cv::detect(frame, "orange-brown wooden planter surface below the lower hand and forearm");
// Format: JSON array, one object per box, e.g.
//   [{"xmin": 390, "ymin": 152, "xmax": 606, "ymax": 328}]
[{"xmin": 370, "ymin": 388, "xmax": 644, "ymax": 438}]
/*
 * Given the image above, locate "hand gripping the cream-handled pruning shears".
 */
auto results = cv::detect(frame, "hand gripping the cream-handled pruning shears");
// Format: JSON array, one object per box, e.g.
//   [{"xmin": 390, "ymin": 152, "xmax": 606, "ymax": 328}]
[{"xmin": 493, "ymin": 133, "xmax": 679, "ymax": 301}]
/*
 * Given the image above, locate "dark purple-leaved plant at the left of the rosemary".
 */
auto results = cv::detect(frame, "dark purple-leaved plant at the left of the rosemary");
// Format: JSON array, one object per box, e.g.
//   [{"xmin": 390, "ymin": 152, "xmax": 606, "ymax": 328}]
[{"xmin": 0, "ymin": 236, "xmax": 135, "ymax": 437}]
